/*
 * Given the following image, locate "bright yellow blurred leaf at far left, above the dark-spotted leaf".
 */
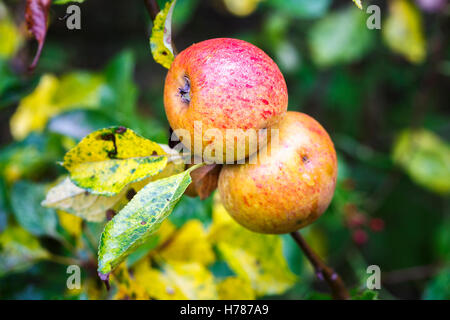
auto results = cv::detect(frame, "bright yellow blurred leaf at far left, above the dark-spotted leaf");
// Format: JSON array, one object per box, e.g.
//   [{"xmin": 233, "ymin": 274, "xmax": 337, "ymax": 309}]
[{"xmin": 10, "ymin": 74, "xmax": 59, "ymax": 140}]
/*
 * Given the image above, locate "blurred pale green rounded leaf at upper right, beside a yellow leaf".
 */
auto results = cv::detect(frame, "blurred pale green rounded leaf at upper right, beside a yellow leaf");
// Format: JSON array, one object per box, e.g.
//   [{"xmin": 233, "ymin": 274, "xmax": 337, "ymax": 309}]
[{"xmin": 308, "ymin": 6, "xmax": 374, "ymax": 67}]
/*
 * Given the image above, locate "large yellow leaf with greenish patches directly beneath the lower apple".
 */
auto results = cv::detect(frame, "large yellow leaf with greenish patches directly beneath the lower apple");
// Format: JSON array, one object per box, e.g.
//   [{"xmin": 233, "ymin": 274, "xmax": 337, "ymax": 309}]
[{"xmin": 209, "ymin": 194, "xmax": 297, "ymax": 296}]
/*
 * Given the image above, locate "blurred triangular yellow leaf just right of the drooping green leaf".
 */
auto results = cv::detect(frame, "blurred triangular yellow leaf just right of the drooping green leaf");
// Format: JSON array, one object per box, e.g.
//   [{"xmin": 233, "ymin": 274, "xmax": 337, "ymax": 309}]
[{"xmin": 160, "ymin": 220, "xmax": 215, "ymax": 265}]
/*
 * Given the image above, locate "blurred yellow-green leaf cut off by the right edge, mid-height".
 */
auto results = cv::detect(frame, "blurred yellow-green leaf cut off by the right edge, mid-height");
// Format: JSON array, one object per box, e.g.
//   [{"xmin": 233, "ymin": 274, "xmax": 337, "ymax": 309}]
[{"xmin": 392, "ymin": 129, "xmax": 450, "ymax": 194}]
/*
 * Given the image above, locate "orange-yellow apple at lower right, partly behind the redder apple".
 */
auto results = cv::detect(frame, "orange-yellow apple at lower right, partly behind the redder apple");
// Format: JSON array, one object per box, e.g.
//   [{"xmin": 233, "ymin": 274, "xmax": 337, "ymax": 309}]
[{"xmin": 219, "ymin": 112, "xmax": 337, "ymax": 234}]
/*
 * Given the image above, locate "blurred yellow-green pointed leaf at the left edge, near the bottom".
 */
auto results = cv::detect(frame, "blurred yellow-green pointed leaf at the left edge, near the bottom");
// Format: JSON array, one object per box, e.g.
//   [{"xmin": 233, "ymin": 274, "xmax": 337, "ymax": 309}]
[{"xmin": 0, "ymin": 227, "xmax": 49, "ymax": 277}]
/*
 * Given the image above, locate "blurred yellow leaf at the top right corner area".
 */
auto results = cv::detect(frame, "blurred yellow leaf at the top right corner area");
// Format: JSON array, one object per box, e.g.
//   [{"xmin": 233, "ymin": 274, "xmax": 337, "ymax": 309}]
[{"xmin": 382, "ymin": 0, "xmax": 426, "ymax": 63}]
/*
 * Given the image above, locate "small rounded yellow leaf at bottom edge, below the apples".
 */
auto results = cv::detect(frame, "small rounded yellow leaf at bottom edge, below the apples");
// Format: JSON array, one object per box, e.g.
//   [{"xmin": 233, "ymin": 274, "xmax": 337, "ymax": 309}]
[{"xmin": 217, "ymin": 277, "xmax": 256, "ymax": 300}]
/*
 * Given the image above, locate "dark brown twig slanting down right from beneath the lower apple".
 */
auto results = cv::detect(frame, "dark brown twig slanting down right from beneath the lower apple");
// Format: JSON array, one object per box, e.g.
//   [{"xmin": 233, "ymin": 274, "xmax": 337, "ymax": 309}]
[{"xmin": 291, "ymin": 231, "xmax": 350, "ymax": 300}]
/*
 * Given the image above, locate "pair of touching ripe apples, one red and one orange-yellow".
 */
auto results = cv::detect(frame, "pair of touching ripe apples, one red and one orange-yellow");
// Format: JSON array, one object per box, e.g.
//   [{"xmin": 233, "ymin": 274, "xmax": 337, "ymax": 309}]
[{"xmin": 164, "ymin": 38, "xmax": 337, "ymax": 233}]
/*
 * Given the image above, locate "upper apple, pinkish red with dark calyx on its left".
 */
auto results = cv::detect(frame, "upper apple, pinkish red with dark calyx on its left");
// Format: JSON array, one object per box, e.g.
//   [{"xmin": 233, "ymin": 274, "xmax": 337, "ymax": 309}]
[{"xmin": 164, "ymin": 38, "xmax": 288, "ymax": 162}]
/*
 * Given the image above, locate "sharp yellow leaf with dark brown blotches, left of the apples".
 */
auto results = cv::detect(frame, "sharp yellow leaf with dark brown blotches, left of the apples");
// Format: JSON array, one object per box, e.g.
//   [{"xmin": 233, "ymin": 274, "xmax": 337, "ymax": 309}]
[{"xmin": 63, "ymin": 127, "xmax": 168, "ymax": 196}]
